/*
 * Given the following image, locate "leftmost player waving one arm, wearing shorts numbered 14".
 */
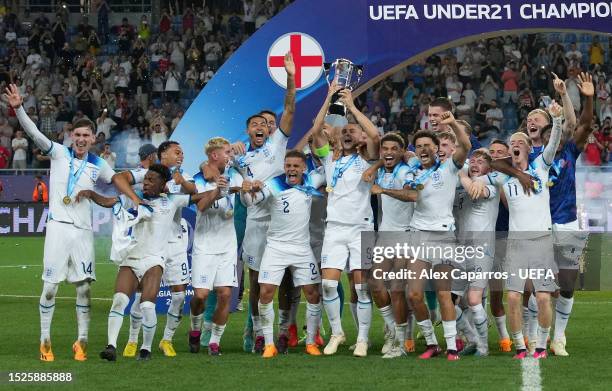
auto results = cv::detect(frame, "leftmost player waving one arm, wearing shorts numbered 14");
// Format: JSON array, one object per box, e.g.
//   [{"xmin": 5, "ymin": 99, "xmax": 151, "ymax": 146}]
[{"xmin": 4, "ymin": 84, "xmax": 115, "ymax": 361}]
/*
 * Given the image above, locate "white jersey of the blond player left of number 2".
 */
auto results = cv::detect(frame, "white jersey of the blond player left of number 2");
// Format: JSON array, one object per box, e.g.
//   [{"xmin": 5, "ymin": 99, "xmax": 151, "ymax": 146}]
[{"xmin": 193, "ymin": 168, "xmax": 242, "ymax": 254}]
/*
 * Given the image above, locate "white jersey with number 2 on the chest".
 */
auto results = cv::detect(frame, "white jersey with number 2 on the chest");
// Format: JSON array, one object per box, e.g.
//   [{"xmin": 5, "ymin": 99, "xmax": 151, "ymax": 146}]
[{"xmin": 264, "ymin": 171, "xmax": 325, "ymax": 249}]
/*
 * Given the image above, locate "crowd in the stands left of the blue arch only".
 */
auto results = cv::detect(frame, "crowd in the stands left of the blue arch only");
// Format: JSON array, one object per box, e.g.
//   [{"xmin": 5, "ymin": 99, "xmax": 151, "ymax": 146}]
[{"xmin": 0, "ymin": 0, "xmax": 288, "ymax": 169}]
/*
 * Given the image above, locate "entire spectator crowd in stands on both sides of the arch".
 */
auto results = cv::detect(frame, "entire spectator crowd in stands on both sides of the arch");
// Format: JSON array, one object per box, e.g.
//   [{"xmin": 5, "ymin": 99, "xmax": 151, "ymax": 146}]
[{"xmin": 0, "ymin": 4, "xmax": 612, "ymax": 169}]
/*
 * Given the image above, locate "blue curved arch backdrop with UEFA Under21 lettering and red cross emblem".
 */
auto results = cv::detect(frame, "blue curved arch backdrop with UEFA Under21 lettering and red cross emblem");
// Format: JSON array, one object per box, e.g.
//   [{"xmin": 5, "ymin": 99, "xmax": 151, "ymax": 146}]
[{"xmin": 173, "ymin": 0, "xmax": 612, "ymax": 172}]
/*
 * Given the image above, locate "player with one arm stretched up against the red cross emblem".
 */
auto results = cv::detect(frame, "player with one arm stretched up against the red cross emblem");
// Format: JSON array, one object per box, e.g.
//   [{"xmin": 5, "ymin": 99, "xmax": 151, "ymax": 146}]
[{"xmin": 235, "ymin": 53, "xmax": 296, "ymax": 353}]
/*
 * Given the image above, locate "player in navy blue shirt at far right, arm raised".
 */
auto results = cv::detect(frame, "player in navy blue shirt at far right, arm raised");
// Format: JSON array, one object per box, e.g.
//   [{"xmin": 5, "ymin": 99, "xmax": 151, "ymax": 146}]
[{"xmin": 542, "ymin": 73, "xmax": 594, "ymax": 356}]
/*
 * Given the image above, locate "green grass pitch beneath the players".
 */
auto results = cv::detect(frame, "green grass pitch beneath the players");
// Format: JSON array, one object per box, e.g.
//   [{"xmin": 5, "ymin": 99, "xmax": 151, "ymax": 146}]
[{"xmin": 0, "ymin": 237, "xmax": 612, "ymax": 391}]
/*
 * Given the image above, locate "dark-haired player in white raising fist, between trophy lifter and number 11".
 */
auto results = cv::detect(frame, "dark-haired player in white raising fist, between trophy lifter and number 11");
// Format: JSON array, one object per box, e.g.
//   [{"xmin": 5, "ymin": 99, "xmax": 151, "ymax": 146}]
[{"xmin": 409, "ymin": 112, "xmax": 471, "ymax": 360}]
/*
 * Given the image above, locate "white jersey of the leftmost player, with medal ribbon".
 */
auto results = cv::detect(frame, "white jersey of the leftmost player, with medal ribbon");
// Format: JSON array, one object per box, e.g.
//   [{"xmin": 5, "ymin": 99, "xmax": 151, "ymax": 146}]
[{"xmin": 47, "ymin": 143, "xmax": 115, "ymax": 230}]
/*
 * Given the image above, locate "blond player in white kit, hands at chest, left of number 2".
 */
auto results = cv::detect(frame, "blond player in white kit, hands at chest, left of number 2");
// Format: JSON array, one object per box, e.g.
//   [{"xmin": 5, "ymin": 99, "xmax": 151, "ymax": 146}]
[{"xmin": 189, "ymin": 137, "xmax": 242, "ymax": 356}]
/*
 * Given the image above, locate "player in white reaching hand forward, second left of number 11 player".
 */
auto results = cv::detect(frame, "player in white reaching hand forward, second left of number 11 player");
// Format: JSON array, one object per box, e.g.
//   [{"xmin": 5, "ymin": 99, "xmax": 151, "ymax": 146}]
[{"xmin": 453, "ymin": 149, "xmax": 500, "ymax": 356}]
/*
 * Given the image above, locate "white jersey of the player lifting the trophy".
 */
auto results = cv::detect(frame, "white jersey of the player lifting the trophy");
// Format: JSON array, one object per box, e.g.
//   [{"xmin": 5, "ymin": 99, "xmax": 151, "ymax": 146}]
[{"xmin": 322, "ymin": 153, "xmax": 374, "ymax": 225}]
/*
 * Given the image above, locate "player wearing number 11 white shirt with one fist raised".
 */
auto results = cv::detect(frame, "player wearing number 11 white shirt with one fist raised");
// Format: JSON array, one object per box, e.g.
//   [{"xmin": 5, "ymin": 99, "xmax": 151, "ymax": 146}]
[{"xmin": 491, "ymin": 101, "xmax": 563, "ymax": 359}]
